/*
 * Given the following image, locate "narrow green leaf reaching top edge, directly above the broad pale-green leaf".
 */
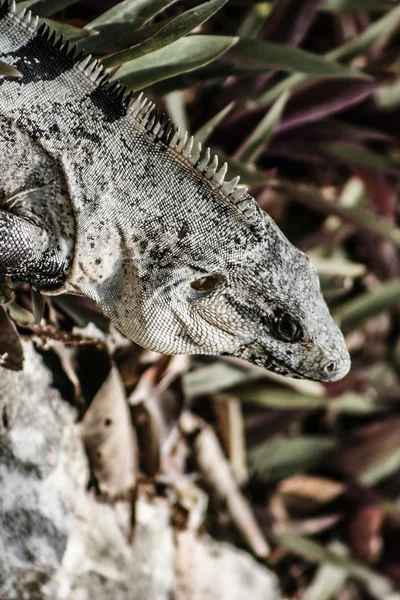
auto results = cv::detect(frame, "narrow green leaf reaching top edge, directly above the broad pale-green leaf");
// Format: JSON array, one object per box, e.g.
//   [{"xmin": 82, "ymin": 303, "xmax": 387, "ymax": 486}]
[{"xmin": 103, "ymin": 0, "xmax": 227, "ymax": 67}]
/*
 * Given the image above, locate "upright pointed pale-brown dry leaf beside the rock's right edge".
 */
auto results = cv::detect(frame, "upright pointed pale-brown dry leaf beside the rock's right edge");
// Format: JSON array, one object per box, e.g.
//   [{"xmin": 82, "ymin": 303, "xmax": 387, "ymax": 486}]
[{"xmin": 81, "ymin": 367, "xmax": 138, "ymax": 499}]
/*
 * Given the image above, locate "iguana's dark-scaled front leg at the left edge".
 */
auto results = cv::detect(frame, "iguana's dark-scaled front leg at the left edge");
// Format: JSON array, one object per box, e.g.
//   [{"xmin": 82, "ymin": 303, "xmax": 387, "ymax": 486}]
[{"xmin": 0, "ymin": 209, "xmax": 72, "ymax": 289}]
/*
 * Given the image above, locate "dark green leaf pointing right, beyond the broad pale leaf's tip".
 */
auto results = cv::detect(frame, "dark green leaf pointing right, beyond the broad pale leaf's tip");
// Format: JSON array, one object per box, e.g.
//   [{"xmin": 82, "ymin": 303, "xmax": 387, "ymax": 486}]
[{"xmin": 225, "ymin": 39, "xmax": 366, "ymax": 78}]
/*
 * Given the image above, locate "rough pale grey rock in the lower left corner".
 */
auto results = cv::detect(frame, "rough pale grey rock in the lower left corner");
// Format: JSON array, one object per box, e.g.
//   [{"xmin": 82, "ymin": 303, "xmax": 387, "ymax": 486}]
[{"xmin": 0, "ymin": 343, "xmax": 279, "ymax": 600}]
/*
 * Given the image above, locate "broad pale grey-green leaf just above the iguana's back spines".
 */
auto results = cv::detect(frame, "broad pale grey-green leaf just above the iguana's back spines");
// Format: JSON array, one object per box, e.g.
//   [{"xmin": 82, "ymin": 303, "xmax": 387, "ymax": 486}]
[{"xmin": 112, "ymin": 35, "xmax": 237, "ymax": 90}]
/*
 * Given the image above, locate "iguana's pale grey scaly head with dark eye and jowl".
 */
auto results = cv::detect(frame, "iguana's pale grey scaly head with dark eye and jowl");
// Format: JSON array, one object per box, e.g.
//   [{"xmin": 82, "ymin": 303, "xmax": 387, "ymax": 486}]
[{"xmin": 124, "ymin": 179, "xmax": 350, "ymax": 381}]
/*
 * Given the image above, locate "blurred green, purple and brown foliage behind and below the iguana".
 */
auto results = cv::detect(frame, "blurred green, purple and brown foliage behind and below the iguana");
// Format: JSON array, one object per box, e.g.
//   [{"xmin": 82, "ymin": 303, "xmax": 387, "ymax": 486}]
[{"xmin": 5, "ymin": 0, "xmax": 400, "ymax": 600}]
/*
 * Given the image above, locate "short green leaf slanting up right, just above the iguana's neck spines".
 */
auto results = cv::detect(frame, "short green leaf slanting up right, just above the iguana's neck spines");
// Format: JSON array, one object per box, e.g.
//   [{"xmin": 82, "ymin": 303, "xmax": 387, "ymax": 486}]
[{"xmin": 238, "ymin": 92, "xmax": 289, "ymax": 164}]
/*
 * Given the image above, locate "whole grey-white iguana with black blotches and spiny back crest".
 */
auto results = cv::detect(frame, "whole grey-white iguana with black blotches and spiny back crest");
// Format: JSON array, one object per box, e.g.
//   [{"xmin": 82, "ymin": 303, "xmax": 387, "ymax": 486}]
[{"xmin": 0, "ymin": 0, "xmax": 350, "ymax": 381}]
